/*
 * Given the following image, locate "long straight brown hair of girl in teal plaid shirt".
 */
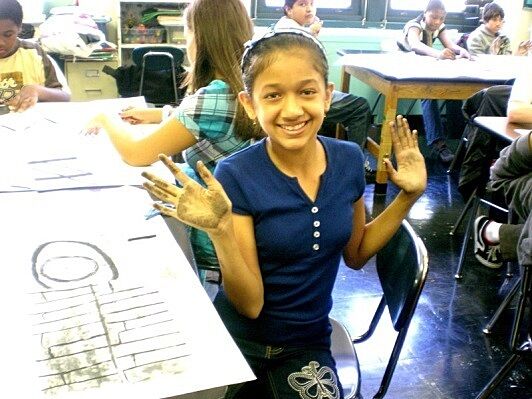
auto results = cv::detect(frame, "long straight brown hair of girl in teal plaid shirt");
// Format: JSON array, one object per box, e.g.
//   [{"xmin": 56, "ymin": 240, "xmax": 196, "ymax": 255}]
[{"xmin": 184, "ymin": 0, "xmax": 262, "ymax": 140}]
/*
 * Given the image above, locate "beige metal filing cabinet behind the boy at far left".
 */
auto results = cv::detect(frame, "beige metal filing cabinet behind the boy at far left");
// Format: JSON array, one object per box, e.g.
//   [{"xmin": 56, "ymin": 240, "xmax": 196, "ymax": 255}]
[{"xmin": 65, "ymin": 59, "xmax": 118, "ymax": 101}]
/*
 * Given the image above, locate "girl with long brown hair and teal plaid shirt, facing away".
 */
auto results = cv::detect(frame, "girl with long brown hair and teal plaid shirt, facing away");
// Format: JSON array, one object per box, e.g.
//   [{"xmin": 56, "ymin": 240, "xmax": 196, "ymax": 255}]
[{"xmin": 88, "ymin": 0, "xmax": 262, "ymax": 288}]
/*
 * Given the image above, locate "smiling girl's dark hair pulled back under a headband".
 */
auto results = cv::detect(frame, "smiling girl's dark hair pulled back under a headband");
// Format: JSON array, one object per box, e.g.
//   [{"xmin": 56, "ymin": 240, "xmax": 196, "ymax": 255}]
[{"xmin": 242, "ymin": 29, "xmax": 329, "ymax": 94}]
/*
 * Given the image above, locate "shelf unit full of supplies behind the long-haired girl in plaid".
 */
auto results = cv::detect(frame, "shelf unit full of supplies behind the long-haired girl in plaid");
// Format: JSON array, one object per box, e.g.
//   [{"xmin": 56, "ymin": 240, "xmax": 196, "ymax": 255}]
[{"xmin": 117, "ymin": 0, "xmax": 191, "ymax": 65}]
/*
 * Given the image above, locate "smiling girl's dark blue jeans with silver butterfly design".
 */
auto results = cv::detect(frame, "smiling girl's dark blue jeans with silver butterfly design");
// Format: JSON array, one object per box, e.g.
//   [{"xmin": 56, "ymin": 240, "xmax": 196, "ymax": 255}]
[{"xmin": 225, "ymin": 339, "xmax": 344, "ymax": 399}]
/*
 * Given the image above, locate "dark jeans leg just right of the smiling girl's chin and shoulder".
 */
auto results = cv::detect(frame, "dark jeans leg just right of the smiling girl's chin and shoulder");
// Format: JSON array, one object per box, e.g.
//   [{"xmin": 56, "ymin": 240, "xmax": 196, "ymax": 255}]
[{"xmin": 324, "ymin": 90, "xmax": 371, "ymax": 148}]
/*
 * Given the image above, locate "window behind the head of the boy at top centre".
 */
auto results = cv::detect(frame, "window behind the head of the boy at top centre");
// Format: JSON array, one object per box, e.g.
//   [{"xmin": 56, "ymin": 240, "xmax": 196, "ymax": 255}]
[{"xmin": 256, "ymin": 0, "xmax": 364, "ymax": 20}]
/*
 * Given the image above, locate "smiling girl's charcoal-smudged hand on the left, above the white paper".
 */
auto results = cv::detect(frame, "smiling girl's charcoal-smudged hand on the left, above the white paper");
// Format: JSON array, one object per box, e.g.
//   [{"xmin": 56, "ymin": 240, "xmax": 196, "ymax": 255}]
[{"xmin": 142, "ymin": 154, "xmax": 232, "ymax": 235}]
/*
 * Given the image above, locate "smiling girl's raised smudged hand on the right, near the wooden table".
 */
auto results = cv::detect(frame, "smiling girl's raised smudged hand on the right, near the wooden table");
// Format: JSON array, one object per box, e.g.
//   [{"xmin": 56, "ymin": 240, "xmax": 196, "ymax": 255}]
[{"xmin": 384, "ymin": 115, "xmax": 427, "ymax": 195}]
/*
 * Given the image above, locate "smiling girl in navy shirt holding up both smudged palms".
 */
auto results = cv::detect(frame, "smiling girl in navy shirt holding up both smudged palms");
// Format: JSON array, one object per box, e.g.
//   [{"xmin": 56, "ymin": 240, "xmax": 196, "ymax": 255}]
[{"xmin": 143, "ymin": 30, "xmax": 426, "ymax": 399}]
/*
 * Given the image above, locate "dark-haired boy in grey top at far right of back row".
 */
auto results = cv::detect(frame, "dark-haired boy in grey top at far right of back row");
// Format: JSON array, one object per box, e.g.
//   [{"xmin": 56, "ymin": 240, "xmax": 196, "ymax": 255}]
[{"xmin": 467, "ymin": 3, "xmax": 532, "ymax": 55}]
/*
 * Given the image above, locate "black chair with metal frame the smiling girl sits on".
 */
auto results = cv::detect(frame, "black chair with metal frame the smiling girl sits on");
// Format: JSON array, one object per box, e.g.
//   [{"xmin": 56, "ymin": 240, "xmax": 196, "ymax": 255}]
[{"xmin": 331, "ymin": 221, "xmax": 428, "ymax": 399}]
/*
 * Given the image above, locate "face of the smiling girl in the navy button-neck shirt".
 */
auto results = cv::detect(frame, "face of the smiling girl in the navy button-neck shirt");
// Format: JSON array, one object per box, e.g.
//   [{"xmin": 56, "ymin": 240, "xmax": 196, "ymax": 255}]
[{"xmin": 239, "ymin": 49, "xmax": 333, "ymax": 150}]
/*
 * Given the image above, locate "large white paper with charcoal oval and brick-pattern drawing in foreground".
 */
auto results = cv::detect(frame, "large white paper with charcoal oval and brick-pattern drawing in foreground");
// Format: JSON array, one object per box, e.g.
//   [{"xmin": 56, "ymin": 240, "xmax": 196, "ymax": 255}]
[{"xmin": 0, "ymin": 187, "xmax": 254, "ymax": 399}]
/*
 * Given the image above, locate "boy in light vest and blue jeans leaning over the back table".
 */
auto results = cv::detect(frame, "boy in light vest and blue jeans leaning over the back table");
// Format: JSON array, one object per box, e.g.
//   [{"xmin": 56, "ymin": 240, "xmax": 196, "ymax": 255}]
[{"xmin": 397, "ymin": 0, "xmax": 470, "ymax": 163}]
